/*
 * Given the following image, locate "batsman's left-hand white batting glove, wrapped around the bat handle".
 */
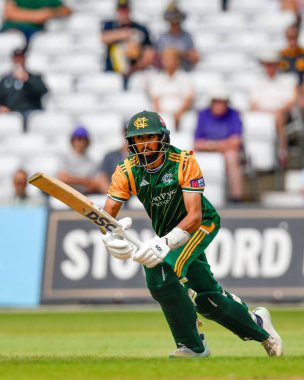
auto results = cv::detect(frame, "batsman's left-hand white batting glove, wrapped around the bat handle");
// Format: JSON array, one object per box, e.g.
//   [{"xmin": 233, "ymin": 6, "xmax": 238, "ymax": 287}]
[{"xmin": 102, "ymin": 217, "xmax": 135, "ymax": 260}]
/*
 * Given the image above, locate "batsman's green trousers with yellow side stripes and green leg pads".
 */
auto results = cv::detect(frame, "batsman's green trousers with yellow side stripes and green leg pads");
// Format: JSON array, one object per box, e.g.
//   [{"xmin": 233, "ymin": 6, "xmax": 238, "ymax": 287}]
[{"xmin": 145, "ymin": 223, "xmax": 269, "ymax": 352}]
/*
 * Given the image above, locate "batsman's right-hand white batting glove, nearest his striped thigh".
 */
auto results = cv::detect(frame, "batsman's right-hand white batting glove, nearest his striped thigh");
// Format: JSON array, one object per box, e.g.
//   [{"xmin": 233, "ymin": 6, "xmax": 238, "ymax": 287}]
[{"xmin": 133, "ymin": 236, "xmax": 170, "ymax": 268}]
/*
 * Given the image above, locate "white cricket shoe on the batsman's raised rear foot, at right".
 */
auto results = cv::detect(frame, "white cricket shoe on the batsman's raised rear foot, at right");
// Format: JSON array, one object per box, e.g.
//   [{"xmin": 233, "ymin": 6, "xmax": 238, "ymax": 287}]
[{"xmin": 253, "ymin": 307, "xmax": 283, "ymax": 356}]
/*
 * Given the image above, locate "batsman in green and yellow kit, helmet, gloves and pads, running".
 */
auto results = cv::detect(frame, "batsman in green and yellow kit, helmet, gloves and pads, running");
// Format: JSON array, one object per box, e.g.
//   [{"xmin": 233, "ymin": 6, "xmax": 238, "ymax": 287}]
[{"xmin": 103, "ymin": 111, "xmax": 283, "ymax": 357}]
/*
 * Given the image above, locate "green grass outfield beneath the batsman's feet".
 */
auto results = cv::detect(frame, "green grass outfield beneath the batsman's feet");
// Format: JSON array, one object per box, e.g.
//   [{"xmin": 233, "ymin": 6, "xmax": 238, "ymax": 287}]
[{"xmin": 0, "ymin": 308, "xmax": 304, "ymax": 380}]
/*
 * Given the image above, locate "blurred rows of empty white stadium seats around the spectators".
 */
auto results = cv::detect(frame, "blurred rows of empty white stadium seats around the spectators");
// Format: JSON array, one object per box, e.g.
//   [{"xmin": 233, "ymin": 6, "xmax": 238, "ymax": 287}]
[{"xmin": 0, "ymin": 0, "xmax": 304, "ymax": 205}]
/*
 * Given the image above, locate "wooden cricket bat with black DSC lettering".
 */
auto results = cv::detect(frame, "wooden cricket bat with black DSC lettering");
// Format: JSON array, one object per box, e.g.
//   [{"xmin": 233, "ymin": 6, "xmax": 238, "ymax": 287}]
[{"xmin": 29, "ymin": 172, "xmax": 141, "ymax": 248}]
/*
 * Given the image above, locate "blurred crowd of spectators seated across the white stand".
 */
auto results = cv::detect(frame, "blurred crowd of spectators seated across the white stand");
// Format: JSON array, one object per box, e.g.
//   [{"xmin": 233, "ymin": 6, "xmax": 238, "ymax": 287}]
[{"xmin": 0, "ymin": 0, "xmax": 304, "ymax": 208}]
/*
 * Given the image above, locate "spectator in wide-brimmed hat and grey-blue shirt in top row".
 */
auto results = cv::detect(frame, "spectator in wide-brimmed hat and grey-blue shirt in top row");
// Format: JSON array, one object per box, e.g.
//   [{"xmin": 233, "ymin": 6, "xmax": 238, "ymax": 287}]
[{"xmin": 156, "ymin": 1, "xmax": 199, "ymax": 71}]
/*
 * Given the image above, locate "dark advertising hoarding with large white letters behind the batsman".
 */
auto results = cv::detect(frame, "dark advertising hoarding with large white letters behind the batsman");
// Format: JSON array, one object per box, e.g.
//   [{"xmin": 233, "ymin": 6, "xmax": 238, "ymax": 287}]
[{"xmin": 42, "ymin": 209, "xmax": 304, "ymax": 303}]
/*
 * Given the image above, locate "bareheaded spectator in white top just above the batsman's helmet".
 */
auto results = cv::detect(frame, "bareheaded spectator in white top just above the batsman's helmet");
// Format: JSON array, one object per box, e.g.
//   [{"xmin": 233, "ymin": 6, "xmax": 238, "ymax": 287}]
[{"xmin": 148, "ymin": 47, "xmax": 194, "ymax": 130}]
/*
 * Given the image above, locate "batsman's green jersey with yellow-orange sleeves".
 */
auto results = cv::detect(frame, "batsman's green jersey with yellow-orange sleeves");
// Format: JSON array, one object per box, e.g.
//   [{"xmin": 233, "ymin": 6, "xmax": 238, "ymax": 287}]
[{"xmin": 108, "ymin": 145, "xmax": 219, "ymax": 236}]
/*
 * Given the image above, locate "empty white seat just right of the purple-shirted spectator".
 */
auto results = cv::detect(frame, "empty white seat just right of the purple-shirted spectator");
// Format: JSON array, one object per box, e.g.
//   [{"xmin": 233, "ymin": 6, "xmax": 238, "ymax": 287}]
[{"xmin": 243, "ymin": 112, "xmax": 277, "ymax": 171}]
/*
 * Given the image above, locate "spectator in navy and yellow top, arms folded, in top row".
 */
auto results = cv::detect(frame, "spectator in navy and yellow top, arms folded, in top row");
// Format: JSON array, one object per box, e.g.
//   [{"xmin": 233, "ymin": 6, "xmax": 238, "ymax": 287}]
[{"xmin": 101, "ymin": 0, "xmax": 155, "ymax": 85}]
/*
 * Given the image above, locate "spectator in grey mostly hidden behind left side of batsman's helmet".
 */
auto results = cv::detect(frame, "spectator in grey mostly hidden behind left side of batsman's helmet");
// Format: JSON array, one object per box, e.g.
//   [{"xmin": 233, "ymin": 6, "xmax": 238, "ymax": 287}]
[{"xmin": 96, "ymin": 132, "xmax": 129, "ymax": 194}]
